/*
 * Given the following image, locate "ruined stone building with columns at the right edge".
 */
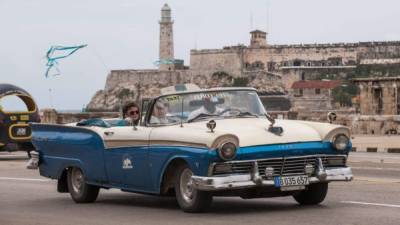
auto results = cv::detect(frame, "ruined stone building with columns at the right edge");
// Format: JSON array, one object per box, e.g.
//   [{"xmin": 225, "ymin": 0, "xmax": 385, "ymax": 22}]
[{"xmin": 352, "ymin": 77, "xmax": 400, "ymax": 115}]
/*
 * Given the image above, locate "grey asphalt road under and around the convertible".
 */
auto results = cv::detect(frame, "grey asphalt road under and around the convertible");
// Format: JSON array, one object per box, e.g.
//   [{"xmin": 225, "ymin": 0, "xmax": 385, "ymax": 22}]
[{"xmin": 0, "ymin": 153, "xmax": 400, "ymax": 225}]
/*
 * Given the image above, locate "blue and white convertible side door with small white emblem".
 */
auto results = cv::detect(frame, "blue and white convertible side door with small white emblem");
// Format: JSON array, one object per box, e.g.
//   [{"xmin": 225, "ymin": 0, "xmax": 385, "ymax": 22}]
[{"xmin": 103, "ymin": 126, "xmax": 151, "ymax": 191}]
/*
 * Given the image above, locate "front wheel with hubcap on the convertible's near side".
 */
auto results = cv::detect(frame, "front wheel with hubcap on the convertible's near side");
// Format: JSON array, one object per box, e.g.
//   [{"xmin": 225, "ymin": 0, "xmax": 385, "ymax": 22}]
[{"xmin": 175, "ymin": 165, "xmax": 212, "ymax": 213}]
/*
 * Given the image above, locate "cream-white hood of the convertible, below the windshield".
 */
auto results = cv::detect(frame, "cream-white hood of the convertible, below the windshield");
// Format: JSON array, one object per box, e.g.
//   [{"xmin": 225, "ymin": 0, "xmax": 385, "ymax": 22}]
[{"xmin": 150, "ymin": 118, "xmax": 350, "ymax": 147}]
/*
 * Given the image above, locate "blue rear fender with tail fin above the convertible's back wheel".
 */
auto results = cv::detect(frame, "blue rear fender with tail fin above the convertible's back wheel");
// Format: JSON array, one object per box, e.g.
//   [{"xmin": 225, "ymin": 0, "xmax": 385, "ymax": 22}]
[{"xmin": 32, "ymin": 123, "xmax": 108, "ymax": 183}]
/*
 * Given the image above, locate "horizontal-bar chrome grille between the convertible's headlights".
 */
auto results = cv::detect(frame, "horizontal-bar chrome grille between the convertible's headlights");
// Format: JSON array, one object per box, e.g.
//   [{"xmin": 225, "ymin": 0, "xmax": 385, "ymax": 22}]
[{"xmin": 212, "ymin": 155, "xmax": 347, "ymax": 177}]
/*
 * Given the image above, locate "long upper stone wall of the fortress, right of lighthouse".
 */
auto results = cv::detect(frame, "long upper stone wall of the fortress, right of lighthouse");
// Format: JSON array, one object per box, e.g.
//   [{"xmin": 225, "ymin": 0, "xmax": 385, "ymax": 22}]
[{"xmin": 198, "ymin": 42, "xmax": 400, "ymax": 70}]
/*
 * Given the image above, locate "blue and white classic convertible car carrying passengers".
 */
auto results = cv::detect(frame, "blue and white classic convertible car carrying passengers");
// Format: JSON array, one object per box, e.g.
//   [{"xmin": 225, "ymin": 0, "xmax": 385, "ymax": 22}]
[{"xmin": 32, "ymin": 85, "xmax": 353, "ymax": 212}]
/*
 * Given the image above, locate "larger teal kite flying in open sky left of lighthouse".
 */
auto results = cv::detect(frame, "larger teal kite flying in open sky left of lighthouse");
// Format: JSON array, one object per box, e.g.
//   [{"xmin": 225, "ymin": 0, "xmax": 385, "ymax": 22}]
[{"xmin": 45, "ymin": 45, "xmax": 87, "ymax": 78}]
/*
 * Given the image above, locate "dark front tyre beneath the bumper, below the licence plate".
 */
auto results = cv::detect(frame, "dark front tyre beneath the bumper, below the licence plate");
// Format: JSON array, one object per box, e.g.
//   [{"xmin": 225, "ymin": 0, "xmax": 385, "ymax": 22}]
[{"xmin": 293, "ymin": 183, "xmax": 328, "ymax": 205}]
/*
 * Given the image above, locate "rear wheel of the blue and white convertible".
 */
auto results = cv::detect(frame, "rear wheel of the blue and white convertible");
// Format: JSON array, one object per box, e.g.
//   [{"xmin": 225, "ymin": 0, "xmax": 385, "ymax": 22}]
[{"xmin": 67, "ymin": 167, "xmax": 100, "ymax": 203}]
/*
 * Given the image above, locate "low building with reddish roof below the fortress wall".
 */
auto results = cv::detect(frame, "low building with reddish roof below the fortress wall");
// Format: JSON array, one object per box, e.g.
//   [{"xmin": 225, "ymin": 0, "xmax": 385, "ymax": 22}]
[{"xmin": 290, "ymin": 80, "xmax": 341, "ymax": 111}]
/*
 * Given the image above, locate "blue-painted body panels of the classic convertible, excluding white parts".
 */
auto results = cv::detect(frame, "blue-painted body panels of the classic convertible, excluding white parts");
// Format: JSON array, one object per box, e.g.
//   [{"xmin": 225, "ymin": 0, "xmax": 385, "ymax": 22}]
[{"xmin": 32, "ymin": 124, "xmax": 351, "ymax": 194}]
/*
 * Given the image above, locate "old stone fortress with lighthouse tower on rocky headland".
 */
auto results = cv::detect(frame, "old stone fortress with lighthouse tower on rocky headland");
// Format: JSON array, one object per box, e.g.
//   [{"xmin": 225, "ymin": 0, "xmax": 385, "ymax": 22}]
[{"xmin": 87, "ymin": 4, "xmax": 400, "ymax": 123}]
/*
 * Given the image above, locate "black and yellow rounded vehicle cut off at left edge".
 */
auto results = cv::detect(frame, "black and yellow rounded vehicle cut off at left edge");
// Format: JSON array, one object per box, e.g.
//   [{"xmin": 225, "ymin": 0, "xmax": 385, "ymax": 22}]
[{"xmin": 0, "ymin": 84, "xmax": 40, "ymax": 155}]
